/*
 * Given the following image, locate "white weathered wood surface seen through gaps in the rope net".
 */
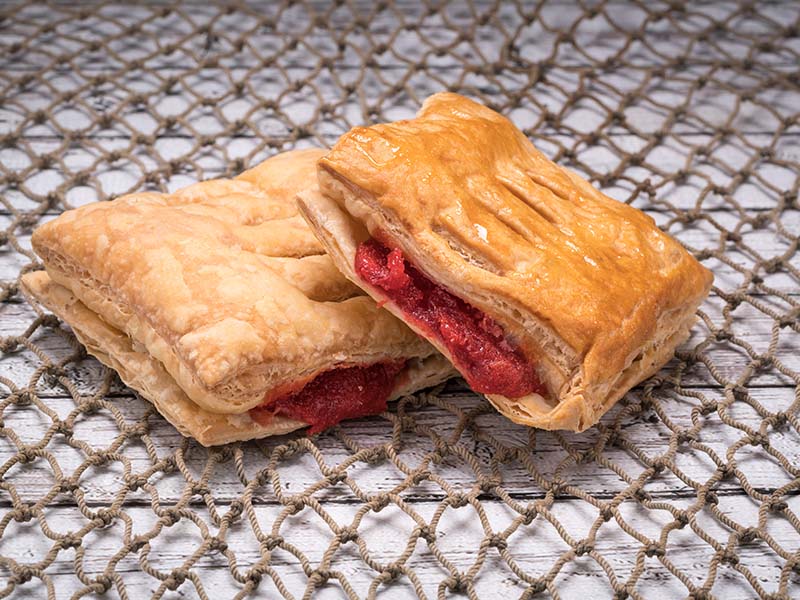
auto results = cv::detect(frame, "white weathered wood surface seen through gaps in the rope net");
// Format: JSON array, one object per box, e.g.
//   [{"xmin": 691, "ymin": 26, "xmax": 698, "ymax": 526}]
[{"xmin": 0, "ymin": 4, "xmax": 800, "ymax": 599}]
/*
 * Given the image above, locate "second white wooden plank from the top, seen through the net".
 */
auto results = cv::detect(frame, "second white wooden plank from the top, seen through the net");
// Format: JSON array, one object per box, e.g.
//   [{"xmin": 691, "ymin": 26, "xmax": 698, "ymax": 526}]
[{"xmin": 0, "ymin": 61, "xmax": 800, "ymax": 129}]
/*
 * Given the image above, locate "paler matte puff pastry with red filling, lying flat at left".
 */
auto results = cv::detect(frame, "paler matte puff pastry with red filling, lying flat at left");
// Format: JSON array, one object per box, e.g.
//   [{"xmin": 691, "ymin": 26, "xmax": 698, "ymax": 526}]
[{"xmin": 23, "ymin": 150, "xmax": 452, "ymax": 445}]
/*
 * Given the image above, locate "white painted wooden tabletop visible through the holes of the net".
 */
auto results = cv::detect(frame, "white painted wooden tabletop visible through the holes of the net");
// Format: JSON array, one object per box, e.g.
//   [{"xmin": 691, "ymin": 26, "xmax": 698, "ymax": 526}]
[{"xmin": 0, "ymin": 2, "xmax": 800, "ymax": 599}]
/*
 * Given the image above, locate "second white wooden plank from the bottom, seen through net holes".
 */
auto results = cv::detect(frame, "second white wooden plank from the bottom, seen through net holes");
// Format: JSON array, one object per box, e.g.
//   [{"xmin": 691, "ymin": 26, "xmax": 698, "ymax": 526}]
[{"xmin": 0, "ymin": 382, "xmax": 800, "ymax": 506}]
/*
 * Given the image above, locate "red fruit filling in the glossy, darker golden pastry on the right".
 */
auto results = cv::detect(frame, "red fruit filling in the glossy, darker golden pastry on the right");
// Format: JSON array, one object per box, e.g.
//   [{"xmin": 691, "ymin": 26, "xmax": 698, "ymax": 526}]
[{"xmin": 355, "ymin": 239, "xmax": 546, "ymax": 398}]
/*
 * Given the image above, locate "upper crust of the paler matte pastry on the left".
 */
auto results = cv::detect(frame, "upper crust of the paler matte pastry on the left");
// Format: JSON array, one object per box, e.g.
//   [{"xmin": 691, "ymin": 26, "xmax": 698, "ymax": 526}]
[{"xmin": 33, "ymin": 150, "xmax": 450, "ymax": 413}]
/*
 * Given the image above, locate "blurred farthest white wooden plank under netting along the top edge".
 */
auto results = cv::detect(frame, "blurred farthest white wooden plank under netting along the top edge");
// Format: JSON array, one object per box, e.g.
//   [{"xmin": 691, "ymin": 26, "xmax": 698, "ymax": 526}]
[{"xmin": 0, "ymin": 1, "xmax": 796, "ymax": 71}]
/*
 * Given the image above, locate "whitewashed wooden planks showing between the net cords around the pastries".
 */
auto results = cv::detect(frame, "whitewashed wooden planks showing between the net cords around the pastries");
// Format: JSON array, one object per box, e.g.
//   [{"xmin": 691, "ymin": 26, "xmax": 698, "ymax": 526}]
[{"xmin": 0, "ymin": 3, "xmax": 800, "ymax": 598}]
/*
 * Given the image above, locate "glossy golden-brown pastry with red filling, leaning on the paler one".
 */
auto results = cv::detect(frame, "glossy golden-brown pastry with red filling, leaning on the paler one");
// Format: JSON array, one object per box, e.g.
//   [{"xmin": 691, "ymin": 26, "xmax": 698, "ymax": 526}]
[{"xmin": 299, "ymin": 93, "xmax": 712, "ymax": 431}]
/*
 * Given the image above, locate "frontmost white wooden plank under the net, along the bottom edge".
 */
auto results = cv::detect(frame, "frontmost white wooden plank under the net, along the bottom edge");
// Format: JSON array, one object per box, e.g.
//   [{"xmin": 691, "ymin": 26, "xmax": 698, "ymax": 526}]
[{"xmin": 0, "ymin": 497, "xmax": 800, "ymax": 599}]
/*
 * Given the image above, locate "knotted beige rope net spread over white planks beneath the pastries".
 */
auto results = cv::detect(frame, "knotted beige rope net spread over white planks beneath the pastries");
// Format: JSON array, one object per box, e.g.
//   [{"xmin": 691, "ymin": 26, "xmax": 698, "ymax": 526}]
[{"xmin": 0, "ymin": 1, "xmax": 800, "ymax": 599}]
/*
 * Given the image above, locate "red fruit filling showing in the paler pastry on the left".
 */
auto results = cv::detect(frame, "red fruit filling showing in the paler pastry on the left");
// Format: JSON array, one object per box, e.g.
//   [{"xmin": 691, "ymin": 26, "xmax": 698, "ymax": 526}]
[{"xmin": 250, "ymin": 361, "xmax": 405, "ymax": 435}]
